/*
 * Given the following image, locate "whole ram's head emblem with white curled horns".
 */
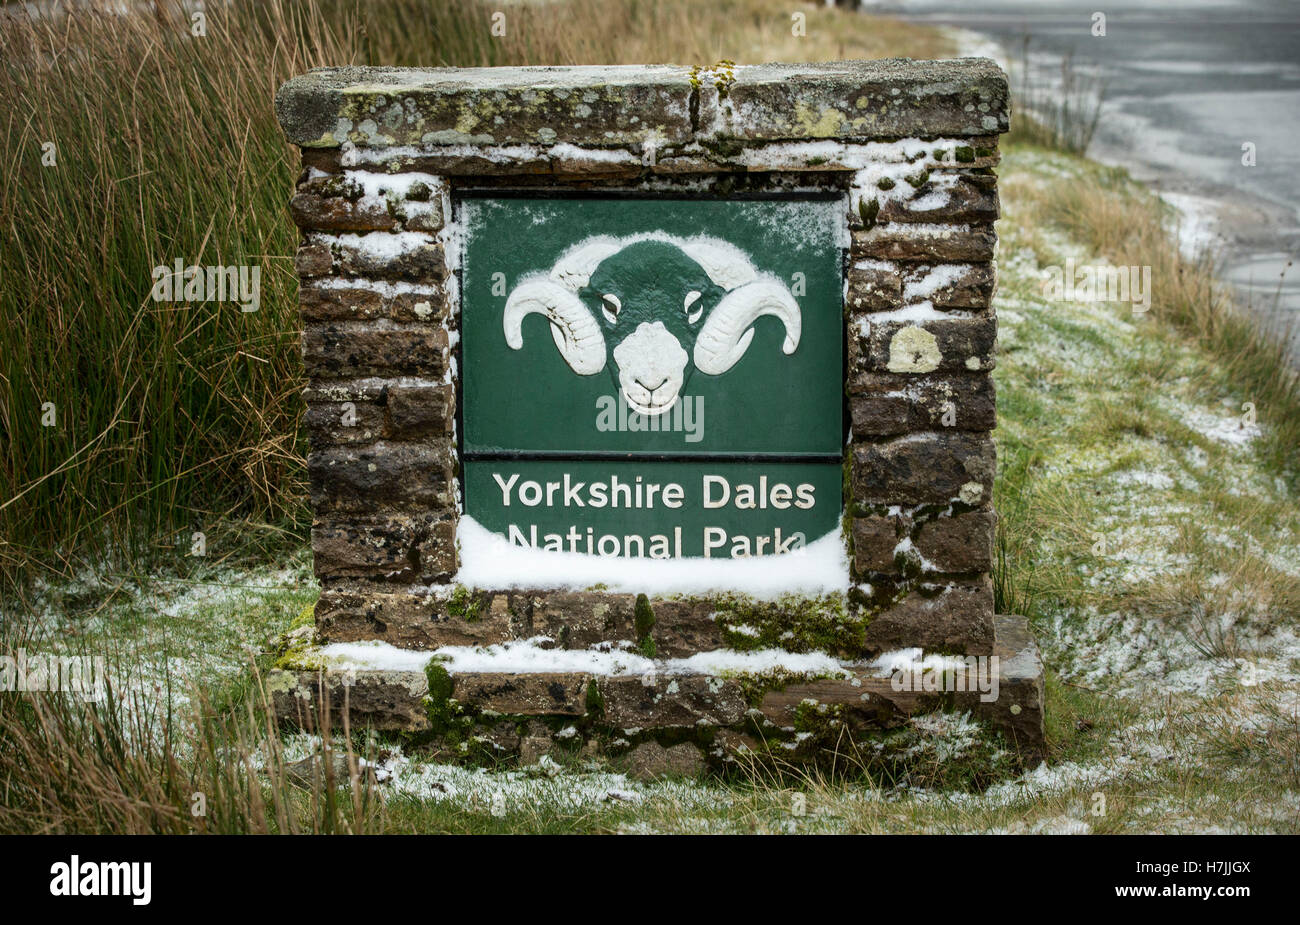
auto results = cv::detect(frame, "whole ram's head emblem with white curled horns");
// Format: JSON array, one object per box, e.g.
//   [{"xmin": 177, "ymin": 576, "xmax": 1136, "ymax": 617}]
[{"xmin": 503, "ymin": 233, "xmax": 801, "ymax": 414}]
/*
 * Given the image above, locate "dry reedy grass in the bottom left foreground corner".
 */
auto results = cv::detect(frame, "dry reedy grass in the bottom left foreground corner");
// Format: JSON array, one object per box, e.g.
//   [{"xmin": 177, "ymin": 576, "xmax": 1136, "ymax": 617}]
[{"xmin": 0, "ymin": 670, "xmax": 384, "ymax": 834}]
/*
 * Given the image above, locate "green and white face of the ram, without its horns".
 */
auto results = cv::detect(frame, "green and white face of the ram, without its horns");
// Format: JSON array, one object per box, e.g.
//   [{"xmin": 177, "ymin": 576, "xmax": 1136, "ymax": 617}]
[{"xmin": 580, "ymin": 240, "xmax": 725, "ymax": 414}]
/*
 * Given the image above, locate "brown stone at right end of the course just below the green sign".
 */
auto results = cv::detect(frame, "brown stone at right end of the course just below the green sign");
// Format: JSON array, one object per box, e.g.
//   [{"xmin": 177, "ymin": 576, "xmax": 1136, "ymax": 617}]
[{"xmin": 866, "ymin": 576, "xmax": 993, "ymax": 655}]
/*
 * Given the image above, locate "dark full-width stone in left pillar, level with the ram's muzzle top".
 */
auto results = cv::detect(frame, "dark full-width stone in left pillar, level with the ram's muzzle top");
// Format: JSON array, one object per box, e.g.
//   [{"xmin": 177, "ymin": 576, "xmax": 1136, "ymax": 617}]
[{"xmin": 303, "ymin": 321, "xmax": 449, "ymax": 379}]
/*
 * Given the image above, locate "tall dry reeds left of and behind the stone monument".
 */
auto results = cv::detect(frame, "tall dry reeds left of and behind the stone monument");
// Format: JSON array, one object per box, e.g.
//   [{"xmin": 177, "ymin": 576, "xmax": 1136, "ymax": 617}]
[{"xmin": 0, "ymin": 0, "xmax": 949, "ymax": 585}]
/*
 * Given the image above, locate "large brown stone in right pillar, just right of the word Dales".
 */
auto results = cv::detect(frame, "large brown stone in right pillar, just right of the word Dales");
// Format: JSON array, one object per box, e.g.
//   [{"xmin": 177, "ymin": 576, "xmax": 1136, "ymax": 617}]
[{"xmin": 853, "ymin": 433, "xmax": 996, "ymax": 507}]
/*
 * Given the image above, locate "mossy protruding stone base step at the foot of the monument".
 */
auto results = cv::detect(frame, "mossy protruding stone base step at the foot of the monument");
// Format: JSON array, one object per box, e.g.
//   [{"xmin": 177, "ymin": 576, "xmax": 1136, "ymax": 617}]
[{"xmin": 265, "ymin": 615, "xmax": 1045, "ymax": 768}]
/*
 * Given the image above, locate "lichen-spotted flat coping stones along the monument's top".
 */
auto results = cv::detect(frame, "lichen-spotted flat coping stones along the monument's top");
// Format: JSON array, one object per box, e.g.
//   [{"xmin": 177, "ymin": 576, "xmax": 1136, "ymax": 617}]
[{"xmin": 276, "ymin": 58, "xmax": 1008, "ymax": 148}]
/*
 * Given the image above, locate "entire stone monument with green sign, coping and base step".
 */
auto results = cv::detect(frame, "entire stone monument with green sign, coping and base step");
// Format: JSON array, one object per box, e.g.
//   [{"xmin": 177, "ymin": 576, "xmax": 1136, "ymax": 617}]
[{"xmin": 269, "ymin": 58, "xmax": 1043, "ymax": 768}]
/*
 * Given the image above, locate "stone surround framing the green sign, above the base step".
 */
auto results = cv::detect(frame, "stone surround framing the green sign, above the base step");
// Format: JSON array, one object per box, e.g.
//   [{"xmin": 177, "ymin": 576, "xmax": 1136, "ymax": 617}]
[{"xmin": 277, "ymin": 58, "xmax": 1045, "ymax": 763}]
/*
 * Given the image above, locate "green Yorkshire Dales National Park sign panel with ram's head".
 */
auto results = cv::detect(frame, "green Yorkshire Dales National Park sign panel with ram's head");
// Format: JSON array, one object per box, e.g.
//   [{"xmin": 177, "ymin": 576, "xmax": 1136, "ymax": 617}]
[{"xmin": 459, "ymin": 196, "xmax": 845, "ymax": 559}]
